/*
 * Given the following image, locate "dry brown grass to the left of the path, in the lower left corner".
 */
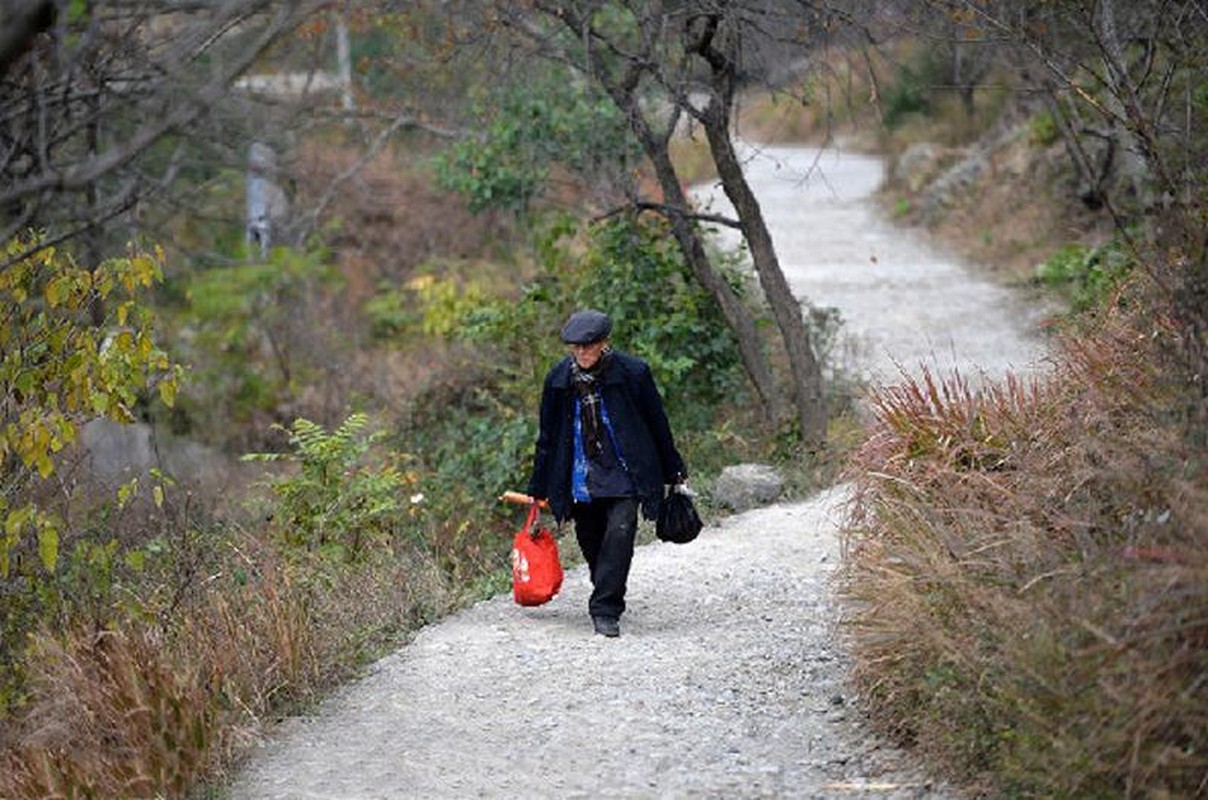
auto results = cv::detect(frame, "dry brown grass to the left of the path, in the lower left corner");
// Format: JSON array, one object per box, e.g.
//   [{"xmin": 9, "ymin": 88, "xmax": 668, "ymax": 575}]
[{"xmin": 0, "ymin": 535, "xmax": 457, "ymax": 800}]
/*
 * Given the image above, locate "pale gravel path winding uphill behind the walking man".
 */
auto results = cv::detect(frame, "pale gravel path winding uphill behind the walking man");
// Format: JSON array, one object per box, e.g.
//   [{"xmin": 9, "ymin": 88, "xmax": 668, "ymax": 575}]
[{"xmin": 231, "ymin": 147, "xmax": 1039, "ymax": 800}]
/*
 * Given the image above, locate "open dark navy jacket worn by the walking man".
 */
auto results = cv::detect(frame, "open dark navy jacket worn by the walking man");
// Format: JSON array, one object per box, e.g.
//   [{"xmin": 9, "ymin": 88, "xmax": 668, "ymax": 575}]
[{"xmin": 528, "ymin": 350, "xmax": 687, "ymax": 522}]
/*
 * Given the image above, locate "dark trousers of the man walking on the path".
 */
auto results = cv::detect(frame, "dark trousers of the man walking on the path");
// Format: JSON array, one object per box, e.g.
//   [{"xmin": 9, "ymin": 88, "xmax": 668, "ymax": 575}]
[{"xmin": 570, "ymin": 497, "xmax": 638, "ymax": 619}]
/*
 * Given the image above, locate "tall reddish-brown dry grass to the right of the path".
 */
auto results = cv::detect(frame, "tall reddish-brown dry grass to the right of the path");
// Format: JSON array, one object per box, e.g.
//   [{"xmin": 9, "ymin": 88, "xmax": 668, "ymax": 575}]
[{"xmin": 844, "ymin": 299, "xmax": 1208, "ymax": 798}]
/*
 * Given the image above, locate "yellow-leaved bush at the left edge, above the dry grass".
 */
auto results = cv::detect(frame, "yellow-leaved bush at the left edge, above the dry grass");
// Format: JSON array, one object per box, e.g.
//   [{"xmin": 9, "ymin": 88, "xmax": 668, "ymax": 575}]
[{"xmin": 0, "ymin": 237, "xmax": 182, "ymax": 578}]
